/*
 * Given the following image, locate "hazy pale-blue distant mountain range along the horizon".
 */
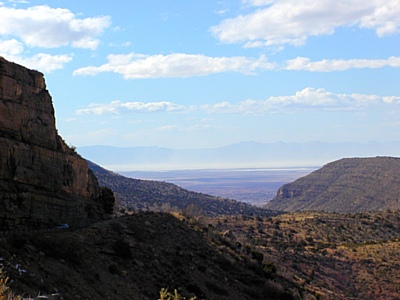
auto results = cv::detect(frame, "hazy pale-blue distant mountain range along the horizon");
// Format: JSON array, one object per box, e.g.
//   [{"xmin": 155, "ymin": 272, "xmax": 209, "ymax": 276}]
[{"xmin": 77, "ymin": 142, "xmax": 400, "ymax": 171}]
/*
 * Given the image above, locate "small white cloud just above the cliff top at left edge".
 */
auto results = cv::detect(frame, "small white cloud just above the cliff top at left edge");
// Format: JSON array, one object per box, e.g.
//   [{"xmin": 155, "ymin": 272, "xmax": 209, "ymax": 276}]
[{"xmin": 0, "ymin": 39, "xmax": 72, "ymax": 72}]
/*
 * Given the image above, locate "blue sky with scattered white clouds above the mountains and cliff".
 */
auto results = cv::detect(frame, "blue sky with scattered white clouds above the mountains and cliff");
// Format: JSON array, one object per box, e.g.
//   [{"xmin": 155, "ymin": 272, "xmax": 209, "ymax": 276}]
[{"xmin": 0, "ymin": 0, "xmax": 400, "ymax": 149}]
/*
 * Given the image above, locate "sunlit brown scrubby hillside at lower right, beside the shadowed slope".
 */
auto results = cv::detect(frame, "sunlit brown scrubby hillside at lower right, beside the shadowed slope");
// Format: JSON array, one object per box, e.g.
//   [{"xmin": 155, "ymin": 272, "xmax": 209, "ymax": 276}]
[{"xmin": 211, "ymin": 211, "xmax": 400, "ymax": 300}]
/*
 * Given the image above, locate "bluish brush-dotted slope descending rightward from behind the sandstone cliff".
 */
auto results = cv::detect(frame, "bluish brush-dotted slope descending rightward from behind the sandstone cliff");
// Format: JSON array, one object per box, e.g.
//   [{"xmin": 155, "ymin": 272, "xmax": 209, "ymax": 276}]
[{"xmin": 88, "ymin": 161, "xmax": 273, "ymax": 216}]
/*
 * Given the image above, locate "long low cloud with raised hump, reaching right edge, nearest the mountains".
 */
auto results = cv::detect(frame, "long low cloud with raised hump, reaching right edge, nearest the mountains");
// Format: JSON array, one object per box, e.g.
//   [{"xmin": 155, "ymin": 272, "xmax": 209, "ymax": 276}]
[{"xmin": 202, "ymin": 88, "xmax": 400, "ymax": 114}]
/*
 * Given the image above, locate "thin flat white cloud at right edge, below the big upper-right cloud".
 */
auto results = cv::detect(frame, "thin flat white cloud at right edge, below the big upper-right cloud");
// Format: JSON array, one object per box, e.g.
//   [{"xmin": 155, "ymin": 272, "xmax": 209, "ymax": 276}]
[{"xmin": 285, "ymin": 56, "xmax": 400, "ymax": 72}]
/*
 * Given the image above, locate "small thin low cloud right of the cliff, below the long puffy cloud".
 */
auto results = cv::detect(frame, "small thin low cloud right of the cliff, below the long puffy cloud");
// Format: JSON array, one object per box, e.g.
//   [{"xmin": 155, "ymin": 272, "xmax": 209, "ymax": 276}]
[{"xmin": 76, "ymin": 100, "xmax": 190, "ymax": 115}]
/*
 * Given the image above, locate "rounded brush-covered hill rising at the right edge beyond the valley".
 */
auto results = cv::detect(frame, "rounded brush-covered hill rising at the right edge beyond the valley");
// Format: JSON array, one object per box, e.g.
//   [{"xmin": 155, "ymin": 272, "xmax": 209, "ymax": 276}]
[{"xmin": 265, "ymin": 157, "xmax": 400, "ymax": 213}]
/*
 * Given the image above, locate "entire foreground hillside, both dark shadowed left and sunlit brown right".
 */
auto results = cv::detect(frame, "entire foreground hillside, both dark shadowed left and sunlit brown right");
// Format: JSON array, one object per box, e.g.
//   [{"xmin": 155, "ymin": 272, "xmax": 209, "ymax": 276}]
[{"xmin": 0, "ymin": 207, "xmax": 400, "ymax": 300}]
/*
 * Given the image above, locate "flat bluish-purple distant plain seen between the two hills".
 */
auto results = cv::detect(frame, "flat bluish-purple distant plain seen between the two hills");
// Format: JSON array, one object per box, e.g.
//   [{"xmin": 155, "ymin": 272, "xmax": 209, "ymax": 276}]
[{"xmin": 118, "ymin": 167, "xmax": 317, "ymax": 206}]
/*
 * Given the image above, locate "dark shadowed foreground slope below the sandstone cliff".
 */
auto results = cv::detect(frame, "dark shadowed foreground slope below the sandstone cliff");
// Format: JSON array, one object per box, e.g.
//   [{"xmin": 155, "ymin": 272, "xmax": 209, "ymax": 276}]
[{"xmin": 0, "ymin": 213, "xmax": 296, "ymax": 300}]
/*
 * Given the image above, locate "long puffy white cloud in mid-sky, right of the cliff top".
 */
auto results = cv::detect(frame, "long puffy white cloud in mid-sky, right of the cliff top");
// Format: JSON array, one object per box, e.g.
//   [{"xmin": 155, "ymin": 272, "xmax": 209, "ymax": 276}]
[{"xmin": 74, "ymin": 53, "xmax": 275, "ymax": 79}]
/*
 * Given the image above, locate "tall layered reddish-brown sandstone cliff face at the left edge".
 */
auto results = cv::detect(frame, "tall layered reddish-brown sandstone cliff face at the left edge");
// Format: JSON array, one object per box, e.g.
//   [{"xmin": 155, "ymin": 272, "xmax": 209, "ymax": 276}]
[{"xmin": 0, "ymin": 57, "xmax": 101, "ymax": 230}]
